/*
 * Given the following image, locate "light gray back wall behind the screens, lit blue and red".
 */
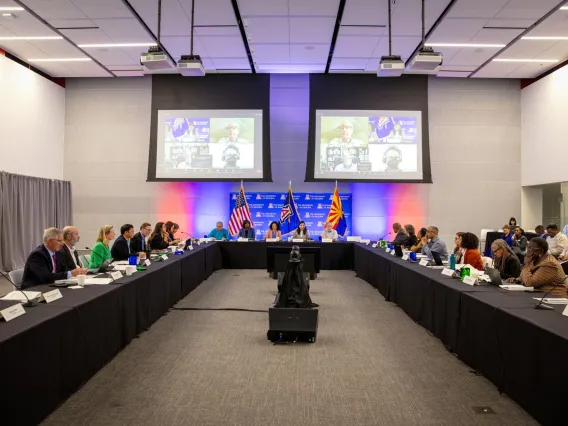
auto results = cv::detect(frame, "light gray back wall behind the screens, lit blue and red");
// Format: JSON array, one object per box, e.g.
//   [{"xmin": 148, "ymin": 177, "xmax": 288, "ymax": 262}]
[{"xmin": 65, "ymin": 76, "xmax": 521, "ymax": 245}]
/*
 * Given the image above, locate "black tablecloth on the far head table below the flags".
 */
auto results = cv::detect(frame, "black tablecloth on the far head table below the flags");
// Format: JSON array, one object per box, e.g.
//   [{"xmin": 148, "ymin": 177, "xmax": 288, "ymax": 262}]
[{"xmin": 216, "ymin": 241, "xmax": 354, "ymax": 270}]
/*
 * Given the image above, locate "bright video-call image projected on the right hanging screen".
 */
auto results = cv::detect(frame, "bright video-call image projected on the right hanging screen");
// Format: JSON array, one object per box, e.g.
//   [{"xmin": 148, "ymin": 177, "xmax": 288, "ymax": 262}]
[{"xmin": 314, "ymin": 110, "xmax": 422, "ymax": 180}]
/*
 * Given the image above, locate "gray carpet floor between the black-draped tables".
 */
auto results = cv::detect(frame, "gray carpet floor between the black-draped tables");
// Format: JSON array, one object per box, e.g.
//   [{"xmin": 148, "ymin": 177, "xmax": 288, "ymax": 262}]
[{"xmin": 43, "ymin": 270, "xmax": 537, "ymax": 426}]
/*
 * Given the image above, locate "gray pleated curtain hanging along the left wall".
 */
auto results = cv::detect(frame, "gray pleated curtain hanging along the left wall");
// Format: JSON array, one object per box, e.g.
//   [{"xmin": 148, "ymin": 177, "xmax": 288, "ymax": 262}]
[{"xmin": 0, "ymin": 171, "xmax": 73, "ymax": 271}]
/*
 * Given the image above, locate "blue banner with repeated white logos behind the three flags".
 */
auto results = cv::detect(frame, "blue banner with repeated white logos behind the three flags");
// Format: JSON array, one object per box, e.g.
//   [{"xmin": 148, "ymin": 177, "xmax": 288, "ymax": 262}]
[{"xmin": 229, "ymin": 191, "xmax": 352, "ymax": 240}]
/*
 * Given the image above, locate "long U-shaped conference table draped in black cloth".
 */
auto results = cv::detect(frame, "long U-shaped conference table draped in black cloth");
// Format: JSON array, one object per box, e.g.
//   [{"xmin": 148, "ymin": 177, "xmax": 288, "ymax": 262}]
[{"xmin": 0, "ymin": 241, "xmax": 568, "ymax": 425}]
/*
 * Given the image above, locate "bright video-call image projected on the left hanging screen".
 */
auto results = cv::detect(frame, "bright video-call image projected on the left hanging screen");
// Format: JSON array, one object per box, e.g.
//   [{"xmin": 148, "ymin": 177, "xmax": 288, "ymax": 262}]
[{"xmin": 156, "ymin": 110, "xmax": 263, "ymax": 179}]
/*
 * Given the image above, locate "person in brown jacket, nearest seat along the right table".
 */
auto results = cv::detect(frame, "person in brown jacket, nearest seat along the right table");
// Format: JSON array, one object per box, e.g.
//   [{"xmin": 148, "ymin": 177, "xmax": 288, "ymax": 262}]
[{"xmin": 507, "ymin": 238, "xmax": 568, "ymax": 297}]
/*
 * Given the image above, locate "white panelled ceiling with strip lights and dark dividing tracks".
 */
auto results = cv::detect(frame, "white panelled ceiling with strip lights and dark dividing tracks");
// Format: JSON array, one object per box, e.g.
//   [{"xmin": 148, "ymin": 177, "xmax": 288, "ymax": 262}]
[{"xmin": 0, "ymin": 0, "xmax": 568, "ymax": 78}]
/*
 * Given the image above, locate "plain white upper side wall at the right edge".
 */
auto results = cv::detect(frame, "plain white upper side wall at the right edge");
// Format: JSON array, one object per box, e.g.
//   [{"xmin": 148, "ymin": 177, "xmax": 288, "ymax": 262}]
[{"xmin": 521, "ymin": 66, "xmax": 568, "ymax": 186}]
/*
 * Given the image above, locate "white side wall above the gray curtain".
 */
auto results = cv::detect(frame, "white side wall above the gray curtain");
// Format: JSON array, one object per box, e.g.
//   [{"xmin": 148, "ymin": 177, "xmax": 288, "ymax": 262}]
[{"xmin": 0, "ymin": 55, "xmax": 65, "ymax": 179}]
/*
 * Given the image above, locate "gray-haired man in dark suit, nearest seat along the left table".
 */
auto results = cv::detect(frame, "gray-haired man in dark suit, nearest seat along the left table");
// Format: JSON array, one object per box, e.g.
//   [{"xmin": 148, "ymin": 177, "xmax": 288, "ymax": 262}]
[{"xmin": 21, "ymin": 228, "xmax": 87, "ymax": 289}]
